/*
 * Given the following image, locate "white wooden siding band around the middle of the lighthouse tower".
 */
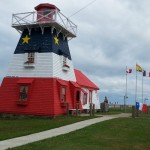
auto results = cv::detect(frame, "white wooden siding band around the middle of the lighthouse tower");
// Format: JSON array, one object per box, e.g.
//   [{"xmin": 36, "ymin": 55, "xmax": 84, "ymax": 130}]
[{"xmin": 7, "ymin": 53, "xmax": 76, "ymax": 81}]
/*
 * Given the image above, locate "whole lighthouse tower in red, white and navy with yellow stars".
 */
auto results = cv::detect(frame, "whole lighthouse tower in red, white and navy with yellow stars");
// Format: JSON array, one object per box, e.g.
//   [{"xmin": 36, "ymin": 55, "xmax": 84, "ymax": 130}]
[{"xmin": 0, "ymin": 3, "xmax": 99, "ymax": 116}]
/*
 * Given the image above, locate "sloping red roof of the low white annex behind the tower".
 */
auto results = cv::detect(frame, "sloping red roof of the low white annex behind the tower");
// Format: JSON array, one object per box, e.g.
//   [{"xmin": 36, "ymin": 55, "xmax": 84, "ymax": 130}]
[{"xmin": 74, "ymin": 69, "xmax": 99, "ymax": 90}]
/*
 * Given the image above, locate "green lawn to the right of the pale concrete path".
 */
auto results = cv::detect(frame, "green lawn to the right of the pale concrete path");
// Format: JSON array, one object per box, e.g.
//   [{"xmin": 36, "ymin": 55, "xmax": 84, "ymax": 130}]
[{"xmin": 13, "ymin": 118, "xmax": 150, "ymax": 150}]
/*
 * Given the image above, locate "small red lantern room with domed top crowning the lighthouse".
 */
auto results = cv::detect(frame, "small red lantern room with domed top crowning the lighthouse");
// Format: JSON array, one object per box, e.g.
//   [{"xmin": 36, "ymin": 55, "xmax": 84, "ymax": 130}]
[{"xmin": 35, "ymin": 3, "xmax": 60, "ymax": 22}]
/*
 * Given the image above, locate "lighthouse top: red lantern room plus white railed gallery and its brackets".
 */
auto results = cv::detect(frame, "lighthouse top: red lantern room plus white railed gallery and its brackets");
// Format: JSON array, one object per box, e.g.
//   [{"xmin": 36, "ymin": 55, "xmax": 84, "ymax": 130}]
[{"xmin": 12, "ymin": 3, "xmax": 77, "ymax": 40}]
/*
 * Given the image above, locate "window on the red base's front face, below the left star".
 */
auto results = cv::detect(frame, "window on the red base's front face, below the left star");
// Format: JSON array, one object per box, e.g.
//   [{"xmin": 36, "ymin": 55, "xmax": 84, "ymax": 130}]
[{"xmin": 19, "ymin": 86, "xmax": 28, "ymax": 101}]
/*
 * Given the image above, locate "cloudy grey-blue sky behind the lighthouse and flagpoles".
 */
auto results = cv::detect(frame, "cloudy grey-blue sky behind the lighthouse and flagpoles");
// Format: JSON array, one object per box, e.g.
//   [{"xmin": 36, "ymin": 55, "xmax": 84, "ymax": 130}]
[{"xmin": 0, "ymin": 0, "xmax": 150, "ymax": 104}]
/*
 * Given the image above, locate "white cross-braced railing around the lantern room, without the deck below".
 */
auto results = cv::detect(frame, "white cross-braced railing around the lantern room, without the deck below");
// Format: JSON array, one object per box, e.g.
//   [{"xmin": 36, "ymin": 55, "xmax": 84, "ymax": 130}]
[{"xmin": 12, "ymin": 9, "xmax": 77, "ymax": 36}]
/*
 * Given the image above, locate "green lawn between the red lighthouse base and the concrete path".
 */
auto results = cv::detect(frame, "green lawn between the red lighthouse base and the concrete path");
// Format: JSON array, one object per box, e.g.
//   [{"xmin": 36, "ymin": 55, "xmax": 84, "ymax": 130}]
[{"xmin": 0, "ymin": 116, "xmax": 96, "ymax": 141}]
